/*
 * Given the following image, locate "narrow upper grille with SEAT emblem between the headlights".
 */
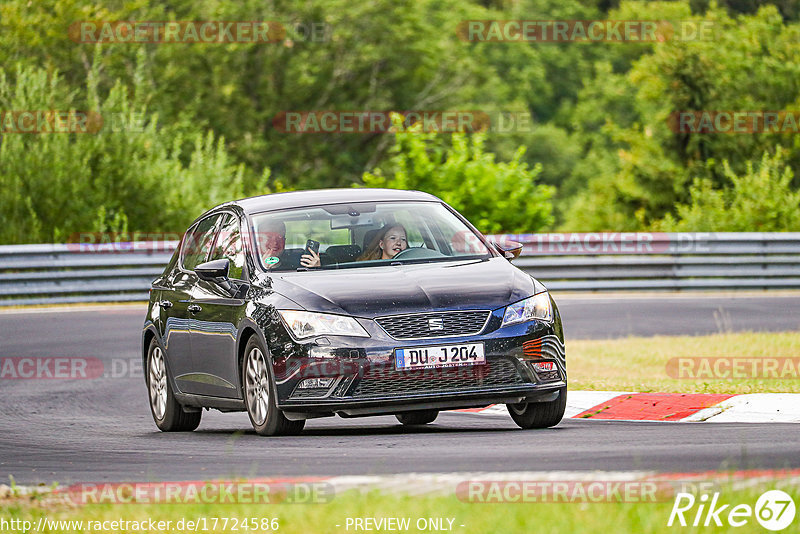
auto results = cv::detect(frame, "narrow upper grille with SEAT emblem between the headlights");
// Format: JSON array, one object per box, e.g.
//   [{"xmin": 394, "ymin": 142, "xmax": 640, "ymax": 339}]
[{"xmin": 375, "ymin": 311, "xmax": 491, "ymax": 339}]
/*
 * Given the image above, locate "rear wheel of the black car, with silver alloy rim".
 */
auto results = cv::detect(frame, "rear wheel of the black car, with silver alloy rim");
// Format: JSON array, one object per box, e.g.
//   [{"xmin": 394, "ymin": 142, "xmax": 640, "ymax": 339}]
[{"xmin": 145, "ymin": 338, "xmax": 203, "ymax": 432}]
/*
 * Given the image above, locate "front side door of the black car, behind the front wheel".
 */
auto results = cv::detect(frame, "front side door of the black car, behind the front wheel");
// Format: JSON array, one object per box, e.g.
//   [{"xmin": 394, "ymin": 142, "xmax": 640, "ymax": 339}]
[{"xmin": 184, "ymin": 213, "xmax": 246, "ymax": 398}]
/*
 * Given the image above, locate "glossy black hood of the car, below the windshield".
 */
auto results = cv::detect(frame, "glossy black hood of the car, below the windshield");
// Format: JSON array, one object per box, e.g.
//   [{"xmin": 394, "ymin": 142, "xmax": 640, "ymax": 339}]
[{"xmin": 272, "ymin": 258, "xmax": 544, "ymax": 318}]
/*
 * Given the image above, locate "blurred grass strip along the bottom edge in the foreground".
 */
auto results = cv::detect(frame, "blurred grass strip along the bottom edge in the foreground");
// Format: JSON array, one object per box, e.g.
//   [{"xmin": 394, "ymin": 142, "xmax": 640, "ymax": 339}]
[{"xmin": 0, "ymin": 483, "xmax": 800, "ymax": 534}]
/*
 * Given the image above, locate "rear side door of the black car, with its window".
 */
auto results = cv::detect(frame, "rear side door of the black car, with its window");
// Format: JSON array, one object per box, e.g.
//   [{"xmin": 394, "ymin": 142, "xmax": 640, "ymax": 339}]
[{"xmin": 160, "ymin": 214, "xmax": 220, "ymax": 393}]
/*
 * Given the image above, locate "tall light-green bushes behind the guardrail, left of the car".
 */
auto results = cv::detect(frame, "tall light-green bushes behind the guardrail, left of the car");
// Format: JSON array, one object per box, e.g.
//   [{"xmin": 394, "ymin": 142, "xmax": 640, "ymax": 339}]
[{"xmin": 0, "ymin": 66, "xmax": 250, "ymax": 243}]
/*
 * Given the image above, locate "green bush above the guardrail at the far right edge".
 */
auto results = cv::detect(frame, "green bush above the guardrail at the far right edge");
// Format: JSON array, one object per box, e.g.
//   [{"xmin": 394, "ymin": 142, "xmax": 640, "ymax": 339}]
[{"xmin": 654, "ymin": 147, "xmax": 800, "ymax": 232}]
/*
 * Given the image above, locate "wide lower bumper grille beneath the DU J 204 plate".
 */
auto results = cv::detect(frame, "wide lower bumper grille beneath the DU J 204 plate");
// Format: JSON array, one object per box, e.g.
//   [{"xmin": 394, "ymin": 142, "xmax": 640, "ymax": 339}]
[{"xmin": 352, "ymin": 358, "xmax": 524, "ymax": 397}]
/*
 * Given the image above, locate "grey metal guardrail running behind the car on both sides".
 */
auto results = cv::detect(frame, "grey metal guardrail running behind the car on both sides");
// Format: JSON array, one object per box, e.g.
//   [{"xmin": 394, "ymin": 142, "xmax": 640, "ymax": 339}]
[{"xmin": 0, "ymin": 232, "xmax": 800, "ymax": 306}]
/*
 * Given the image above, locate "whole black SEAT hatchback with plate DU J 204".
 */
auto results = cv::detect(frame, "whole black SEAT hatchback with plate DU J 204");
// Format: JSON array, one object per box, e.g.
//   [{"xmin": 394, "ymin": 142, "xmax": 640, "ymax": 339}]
[{"xmin": 142, "ymin": 189, "xmax": 567, "ymax": 435}]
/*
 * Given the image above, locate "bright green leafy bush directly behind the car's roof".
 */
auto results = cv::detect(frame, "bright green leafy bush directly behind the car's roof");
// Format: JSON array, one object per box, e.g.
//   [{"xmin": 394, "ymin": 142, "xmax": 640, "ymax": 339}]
[{"xmin": 363, "ymin": 117, "xmax": 554, "ymax": 233}]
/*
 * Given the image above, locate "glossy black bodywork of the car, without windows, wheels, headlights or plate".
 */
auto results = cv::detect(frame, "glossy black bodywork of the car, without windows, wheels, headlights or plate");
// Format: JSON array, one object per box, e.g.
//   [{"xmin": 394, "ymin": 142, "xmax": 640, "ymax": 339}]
[{"xmin": 142, "ymin": 189, "xmax": 567, "ymax": 419}]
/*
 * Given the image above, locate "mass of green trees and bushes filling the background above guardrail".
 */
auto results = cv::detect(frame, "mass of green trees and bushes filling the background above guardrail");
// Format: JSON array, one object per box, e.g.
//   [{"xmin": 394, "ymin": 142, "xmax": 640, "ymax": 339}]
[{"xmin": 0, "ymin": 0, "xmax": 800, "ymax": 243}]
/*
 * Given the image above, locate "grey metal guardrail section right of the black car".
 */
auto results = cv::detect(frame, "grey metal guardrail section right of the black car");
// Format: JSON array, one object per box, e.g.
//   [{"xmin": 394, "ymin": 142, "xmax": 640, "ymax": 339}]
[{"xmin": 494, "ymin": 232, "xmax": 800, "ymax": 291}]
